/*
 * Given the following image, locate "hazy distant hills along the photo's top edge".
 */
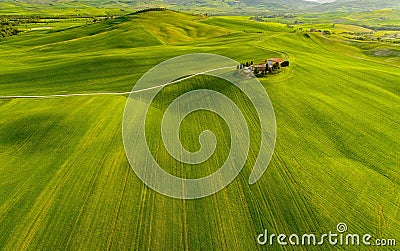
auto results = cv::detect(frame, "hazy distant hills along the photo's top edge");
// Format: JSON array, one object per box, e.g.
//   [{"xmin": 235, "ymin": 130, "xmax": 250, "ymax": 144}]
[{"xmin": 0, "ymin": 0, "xmax": 400, "ymax": 14}]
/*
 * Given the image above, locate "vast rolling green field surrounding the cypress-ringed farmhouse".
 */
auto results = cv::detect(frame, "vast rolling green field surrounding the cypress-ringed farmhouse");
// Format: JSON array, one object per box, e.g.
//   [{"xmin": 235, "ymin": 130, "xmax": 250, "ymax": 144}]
[{"xmin": 0, "ymin": 8, "xmax": 400, "ymax": 250}]
